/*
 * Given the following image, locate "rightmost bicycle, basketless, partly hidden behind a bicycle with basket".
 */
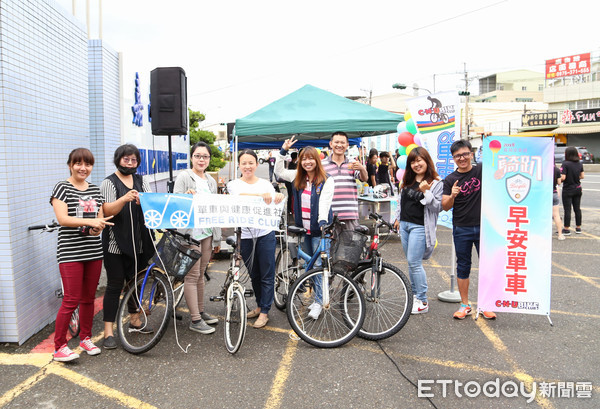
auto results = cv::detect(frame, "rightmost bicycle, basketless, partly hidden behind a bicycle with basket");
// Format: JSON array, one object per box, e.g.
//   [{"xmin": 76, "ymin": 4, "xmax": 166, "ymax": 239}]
[{"xmin": 351, "ymin": 213, "xmax": 413, "ymax": 340}]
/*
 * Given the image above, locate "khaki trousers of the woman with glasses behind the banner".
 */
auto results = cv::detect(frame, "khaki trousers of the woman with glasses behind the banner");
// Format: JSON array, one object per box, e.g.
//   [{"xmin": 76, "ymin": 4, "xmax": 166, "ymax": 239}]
[{"xmin": 183, "ymin": 236, "xmax": 212, "ymax": 321}]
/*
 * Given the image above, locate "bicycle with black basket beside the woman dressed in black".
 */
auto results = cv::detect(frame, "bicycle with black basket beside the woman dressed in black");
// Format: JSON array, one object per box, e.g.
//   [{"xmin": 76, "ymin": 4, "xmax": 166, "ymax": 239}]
[{"xmin": 117, "ymin": 230, "xmax": 201, "ymax": 355}]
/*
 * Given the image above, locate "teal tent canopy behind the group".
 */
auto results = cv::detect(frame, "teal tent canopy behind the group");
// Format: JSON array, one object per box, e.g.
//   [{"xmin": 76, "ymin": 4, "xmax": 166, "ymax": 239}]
[{"xmin": 235, "ymin": 85, "xmax": 404, "ymax": 142}]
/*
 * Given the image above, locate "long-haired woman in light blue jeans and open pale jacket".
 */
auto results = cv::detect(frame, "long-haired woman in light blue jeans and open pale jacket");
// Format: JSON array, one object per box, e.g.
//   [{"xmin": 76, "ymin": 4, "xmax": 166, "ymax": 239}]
[{"xmin": 394, "ymin": 147, "xmax": 443, "ymax": 314}]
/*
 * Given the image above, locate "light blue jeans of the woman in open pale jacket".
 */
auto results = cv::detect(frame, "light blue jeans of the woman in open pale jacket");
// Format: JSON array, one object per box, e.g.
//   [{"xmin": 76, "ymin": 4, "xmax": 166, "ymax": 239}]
[{"xmin": 400, "ymin": 221, "xmax": 427, "ymax": 303}]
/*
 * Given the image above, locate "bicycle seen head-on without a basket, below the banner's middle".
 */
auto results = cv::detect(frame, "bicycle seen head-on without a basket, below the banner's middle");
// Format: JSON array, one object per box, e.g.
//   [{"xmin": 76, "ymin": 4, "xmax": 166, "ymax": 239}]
[{"xmin": 210, "ymin": 227, "xmax": 254, "ymax": 354}]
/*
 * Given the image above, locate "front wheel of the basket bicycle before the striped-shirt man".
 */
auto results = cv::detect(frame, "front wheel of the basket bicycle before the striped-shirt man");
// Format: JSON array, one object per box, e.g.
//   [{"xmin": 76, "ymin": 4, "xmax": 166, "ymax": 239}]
[{"xmin": 287, "ymin": 268, "xmax": 365, "ymax": 348}]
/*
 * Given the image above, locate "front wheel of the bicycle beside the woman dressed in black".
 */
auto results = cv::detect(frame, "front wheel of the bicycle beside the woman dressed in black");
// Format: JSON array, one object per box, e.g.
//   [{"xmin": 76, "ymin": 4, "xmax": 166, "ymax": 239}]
[{"xmin": 117, "ymin": 268, "xmax": 173, "ymax": 354}]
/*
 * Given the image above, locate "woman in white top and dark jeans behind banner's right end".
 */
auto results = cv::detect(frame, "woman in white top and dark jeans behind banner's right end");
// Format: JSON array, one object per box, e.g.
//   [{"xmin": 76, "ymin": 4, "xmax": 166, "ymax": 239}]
[{"xmin": 227, "ymin": 149, "xmax": 284, "ymax": 328}]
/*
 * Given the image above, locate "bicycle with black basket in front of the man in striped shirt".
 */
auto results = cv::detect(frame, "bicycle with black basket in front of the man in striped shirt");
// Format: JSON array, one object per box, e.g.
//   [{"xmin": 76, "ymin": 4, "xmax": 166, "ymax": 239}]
[{"xmin": 286, "ymin": 216, "xmax": 366, "ymax": 348}]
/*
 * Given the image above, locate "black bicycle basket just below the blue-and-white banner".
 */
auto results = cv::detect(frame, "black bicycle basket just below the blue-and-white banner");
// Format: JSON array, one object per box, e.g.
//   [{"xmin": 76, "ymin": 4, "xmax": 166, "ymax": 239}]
[{"xmin": 150, "ymin": 233, "xmax": 201, "ymax": 280}]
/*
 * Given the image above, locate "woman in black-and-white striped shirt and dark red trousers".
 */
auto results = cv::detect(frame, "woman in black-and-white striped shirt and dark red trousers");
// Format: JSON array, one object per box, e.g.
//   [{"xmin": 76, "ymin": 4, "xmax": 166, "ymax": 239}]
[{"xmin": 50, "ymin": 148, "xmax": 112, "ymax": 362}]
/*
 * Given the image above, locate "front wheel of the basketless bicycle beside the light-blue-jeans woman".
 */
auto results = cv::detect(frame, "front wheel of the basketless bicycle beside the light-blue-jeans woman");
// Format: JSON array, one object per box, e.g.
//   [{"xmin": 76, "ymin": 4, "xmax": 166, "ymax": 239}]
[{"xmin": 352, "ymin": 263, "xmax": 412, "ymax": 340}]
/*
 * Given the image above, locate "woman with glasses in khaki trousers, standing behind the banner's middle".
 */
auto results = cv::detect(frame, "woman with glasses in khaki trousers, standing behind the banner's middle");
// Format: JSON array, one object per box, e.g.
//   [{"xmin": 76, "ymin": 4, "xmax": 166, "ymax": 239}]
[{"xmin": 173, "ymin": 141, "xmax": 221, "ymax": 334}]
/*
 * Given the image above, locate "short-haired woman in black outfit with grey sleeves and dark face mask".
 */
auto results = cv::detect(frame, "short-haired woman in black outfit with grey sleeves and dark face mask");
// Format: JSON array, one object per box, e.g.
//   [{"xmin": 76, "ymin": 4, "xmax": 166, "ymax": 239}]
[{"xmin": 100, "ymin": 144, "xmax": 154, "ymax": 349}]
